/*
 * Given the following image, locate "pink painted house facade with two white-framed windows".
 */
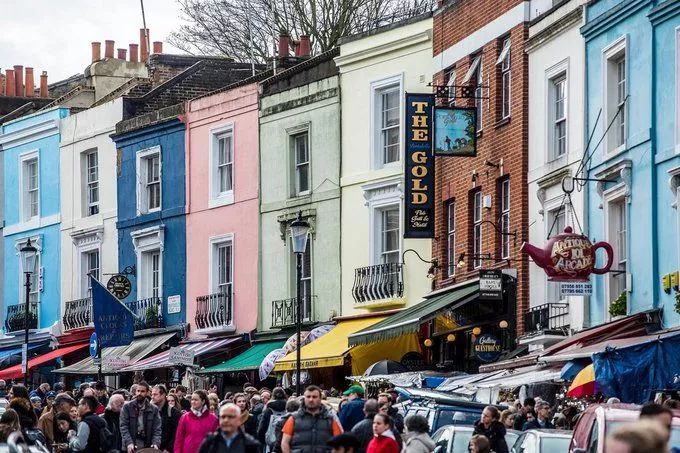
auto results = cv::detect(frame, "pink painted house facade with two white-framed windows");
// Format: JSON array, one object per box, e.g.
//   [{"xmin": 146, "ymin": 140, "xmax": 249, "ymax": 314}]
[{"xmin": 186, "ymin": 79, "xmax": 259, "ymax": 336}]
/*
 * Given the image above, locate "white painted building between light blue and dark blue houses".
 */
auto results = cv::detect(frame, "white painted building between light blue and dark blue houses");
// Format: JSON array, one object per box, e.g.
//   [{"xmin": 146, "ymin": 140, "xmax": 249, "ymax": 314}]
[{"xmin": 60, "ymin": 98, "xmax": 123, "ymax": 331}]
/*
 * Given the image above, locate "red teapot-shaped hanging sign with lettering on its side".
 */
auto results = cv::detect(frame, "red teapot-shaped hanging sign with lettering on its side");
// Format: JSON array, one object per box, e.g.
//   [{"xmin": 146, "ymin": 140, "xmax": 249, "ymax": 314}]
[{"xmin": 520, "ymin": 226, "xmax": 614, "ymax": 282}]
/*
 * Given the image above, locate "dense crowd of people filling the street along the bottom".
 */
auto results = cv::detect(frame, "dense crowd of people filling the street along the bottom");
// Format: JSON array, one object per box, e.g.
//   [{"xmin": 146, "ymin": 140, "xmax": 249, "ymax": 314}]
[{"xmin": 0, "ymin": 380, "xmax": 675, "ymax": 453}]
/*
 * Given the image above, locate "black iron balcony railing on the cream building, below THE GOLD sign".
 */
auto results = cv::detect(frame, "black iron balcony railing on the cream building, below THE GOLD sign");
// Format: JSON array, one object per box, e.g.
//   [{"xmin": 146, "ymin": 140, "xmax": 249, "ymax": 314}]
[{"xmin": 352, "ymin": 263, "xmax": 404, "ymax": 303}]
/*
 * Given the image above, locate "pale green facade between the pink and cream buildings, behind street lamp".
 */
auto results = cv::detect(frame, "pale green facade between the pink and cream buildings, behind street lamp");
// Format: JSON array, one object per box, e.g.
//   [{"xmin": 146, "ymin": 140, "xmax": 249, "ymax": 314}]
[{"xmin": 258, "ymin": 52, "xmax": 341, "ymax": 331}]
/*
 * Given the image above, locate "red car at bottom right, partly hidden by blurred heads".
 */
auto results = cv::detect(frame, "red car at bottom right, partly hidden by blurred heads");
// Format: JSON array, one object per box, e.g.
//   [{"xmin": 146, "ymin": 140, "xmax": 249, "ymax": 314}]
[{"xmin": 569, "ymin": 404, "xmax": 680, "ymax": 453}]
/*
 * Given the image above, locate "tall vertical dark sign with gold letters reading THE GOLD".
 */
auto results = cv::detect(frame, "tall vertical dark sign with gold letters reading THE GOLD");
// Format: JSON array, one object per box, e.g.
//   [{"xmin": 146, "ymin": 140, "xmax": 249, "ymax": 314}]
[{"xmin": 404, "ymin": 93, "xmax": 434, "ymax": 238}]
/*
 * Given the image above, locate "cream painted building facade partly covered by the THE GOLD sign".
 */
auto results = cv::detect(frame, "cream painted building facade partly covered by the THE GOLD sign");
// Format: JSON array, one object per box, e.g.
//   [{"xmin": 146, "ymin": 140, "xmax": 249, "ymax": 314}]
[{"xmin": 335, "ymin": 15, "xmax": 432, "ymax": 316}]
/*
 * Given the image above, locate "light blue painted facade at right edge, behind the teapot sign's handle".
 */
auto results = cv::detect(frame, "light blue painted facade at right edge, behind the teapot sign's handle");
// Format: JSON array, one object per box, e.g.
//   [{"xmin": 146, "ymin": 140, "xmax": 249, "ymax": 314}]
[{"xmin": 581, "ymin": 0, "xmax": 680, "ymax": 327}]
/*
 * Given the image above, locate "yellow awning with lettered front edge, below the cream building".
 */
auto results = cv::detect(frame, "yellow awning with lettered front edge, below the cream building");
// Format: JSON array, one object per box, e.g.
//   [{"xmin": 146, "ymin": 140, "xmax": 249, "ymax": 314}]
[{"xmin": 274, "ymin": 316, "xmax": 386, "ymax": 371}]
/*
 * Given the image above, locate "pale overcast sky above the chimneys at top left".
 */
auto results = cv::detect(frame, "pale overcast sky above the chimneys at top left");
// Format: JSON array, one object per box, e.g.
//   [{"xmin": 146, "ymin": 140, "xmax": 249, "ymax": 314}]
[{"xmin": 0, "ymin": 0, "xmax": 186, "ymax": 85}]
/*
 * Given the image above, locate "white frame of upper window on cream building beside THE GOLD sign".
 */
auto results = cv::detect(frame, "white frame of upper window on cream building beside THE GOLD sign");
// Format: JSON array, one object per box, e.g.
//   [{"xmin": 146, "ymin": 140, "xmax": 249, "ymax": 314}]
[{"xmin": 370, "ymin": 73, "xmax": 404, "ymax": 170}]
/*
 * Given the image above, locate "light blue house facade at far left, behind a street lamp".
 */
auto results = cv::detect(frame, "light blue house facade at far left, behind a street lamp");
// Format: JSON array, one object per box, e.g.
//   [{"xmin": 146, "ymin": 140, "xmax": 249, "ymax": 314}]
[{"xmin": 0, "ymin": 107, "xmax": 69, "ymax": 332}]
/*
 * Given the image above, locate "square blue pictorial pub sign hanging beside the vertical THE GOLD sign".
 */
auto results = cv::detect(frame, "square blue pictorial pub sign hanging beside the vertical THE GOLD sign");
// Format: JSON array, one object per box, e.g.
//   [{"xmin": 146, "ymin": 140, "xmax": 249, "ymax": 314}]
[{"xmin": 434, "ymin": 107, "xmax": 477, "ymax": 157}]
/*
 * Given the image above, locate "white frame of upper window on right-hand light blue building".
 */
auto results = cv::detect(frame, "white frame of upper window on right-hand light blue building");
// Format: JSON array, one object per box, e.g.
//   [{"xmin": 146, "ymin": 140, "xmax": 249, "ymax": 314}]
[{"xmin": 602, "ymin": 35, "xmax": 630, "ymax": 159}]
